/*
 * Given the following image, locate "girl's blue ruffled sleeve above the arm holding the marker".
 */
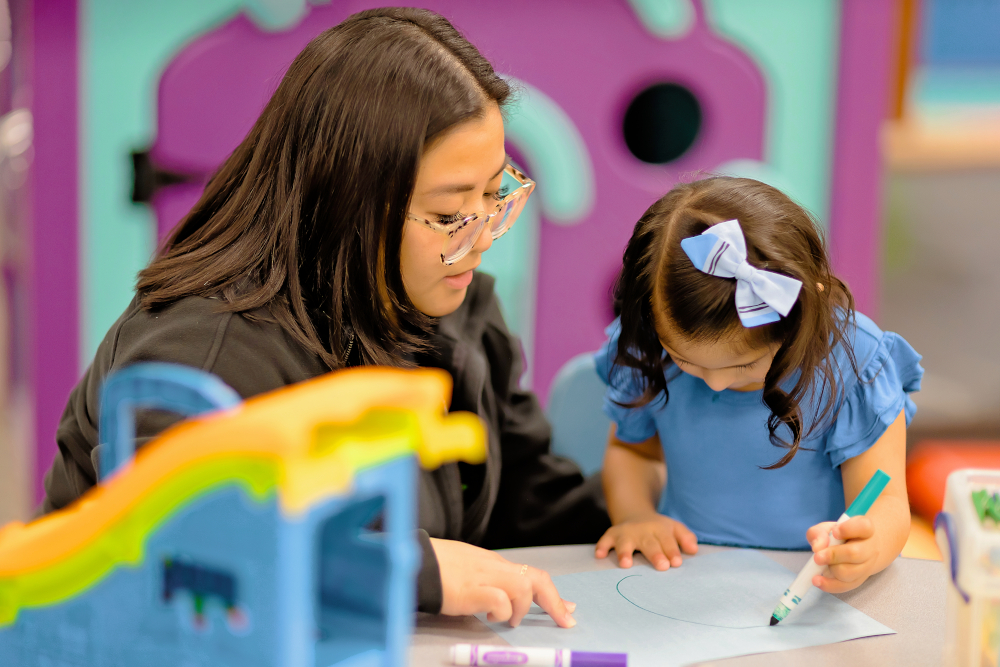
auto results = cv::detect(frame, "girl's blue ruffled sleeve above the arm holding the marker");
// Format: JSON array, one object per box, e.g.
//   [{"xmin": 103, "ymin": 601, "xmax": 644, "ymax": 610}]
[{"xmin": 826, "ymin": 326, "xmax": 924, "ymax": 467}]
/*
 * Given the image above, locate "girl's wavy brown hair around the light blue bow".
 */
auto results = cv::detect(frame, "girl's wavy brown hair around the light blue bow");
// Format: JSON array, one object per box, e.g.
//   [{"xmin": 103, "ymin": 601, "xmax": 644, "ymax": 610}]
[{"xmin": 614, "ymin": 176, "xmax": 858, "ymax": 469}]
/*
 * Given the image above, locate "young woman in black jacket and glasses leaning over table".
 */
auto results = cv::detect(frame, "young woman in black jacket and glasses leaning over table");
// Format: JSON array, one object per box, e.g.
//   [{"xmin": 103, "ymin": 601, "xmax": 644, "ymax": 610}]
[{"xmin": 45, "ymin": 8, "xmax": 610, "ymax": 627}]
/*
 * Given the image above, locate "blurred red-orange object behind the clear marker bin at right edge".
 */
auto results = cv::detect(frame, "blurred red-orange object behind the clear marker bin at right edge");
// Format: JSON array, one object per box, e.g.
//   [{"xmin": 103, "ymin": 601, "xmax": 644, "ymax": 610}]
[{"xmin": 906, "ymin": 440, "xmax": 1000, "ymax": 524}]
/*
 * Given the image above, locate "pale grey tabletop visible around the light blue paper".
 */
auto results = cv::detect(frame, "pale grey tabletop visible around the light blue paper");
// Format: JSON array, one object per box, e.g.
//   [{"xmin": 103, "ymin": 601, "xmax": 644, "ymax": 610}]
[{"xmin": 410, "ymin": 545, "xmax": 947, "ymax": 667}]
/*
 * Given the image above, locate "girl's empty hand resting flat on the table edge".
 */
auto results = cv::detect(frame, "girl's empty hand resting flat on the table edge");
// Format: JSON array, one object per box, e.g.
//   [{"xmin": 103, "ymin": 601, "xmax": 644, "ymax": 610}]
[{"xmin": 594, "ymin": 512, "xmax": 698, "ymax": 571}]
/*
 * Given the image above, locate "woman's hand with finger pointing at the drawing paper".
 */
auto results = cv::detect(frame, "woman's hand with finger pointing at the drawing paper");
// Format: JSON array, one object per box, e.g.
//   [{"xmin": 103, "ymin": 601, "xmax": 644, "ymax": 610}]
[{"xmin": 431, "ymin": 537, "xmax": 576, "ymax": 628}]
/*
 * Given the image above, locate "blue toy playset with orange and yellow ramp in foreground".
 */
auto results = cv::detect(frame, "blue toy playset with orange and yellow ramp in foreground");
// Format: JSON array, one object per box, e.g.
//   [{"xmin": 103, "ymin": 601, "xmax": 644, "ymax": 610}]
[{"xmin": 0, "ymin": 364, "xmax": 485, "ymax": 667}]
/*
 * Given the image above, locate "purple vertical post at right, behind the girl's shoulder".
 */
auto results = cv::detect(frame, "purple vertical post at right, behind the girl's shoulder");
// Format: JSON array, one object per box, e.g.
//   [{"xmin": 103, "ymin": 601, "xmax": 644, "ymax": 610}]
[{"xmin": 830, "ymin": 0, "xmax": 896, "ymax": 321}]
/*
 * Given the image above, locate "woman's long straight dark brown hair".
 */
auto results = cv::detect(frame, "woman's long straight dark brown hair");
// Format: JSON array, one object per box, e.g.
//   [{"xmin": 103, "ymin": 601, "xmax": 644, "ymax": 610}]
[{"xmin": 137, "ymin": 8, "xmax": 510, "ymax": 368}]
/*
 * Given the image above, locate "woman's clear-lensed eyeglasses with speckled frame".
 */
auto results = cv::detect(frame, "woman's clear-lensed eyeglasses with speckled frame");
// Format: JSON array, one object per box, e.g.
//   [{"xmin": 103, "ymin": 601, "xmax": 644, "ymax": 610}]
[{"xmin": 406, "ymin": 164, "xmax": 535, "ymax": 265}]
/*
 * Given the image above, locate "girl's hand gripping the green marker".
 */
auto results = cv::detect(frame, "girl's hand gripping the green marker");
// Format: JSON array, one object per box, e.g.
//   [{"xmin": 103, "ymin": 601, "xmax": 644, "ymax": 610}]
[{"xmin": 806, "ymin": 516, "xmax": 880, "ymax": 593}]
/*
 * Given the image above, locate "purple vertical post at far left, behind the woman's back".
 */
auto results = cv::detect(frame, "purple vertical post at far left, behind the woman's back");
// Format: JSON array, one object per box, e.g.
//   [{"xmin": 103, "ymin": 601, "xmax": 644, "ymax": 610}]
[{"xmin": 29, "ymin": 0, "xmax": 80, "ymax": 498}]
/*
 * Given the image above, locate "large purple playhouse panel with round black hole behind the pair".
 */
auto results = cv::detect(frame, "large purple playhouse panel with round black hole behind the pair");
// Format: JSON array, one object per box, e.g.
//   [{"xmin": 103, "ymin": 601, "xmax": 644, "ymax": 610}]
[{"xmin": 150, "ymin": 0, "xmax": 767, "ymax": 396}]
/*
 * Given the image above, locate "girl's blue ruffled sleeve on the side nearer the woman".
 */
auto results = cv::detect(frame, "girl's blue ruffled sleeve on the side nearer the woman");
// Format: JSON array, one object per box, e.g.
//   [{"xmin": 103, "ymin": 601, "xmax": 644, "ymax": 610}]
[{"xmin": 594, "ymin": 320, "xmax": 658, "ymax": 443}]
